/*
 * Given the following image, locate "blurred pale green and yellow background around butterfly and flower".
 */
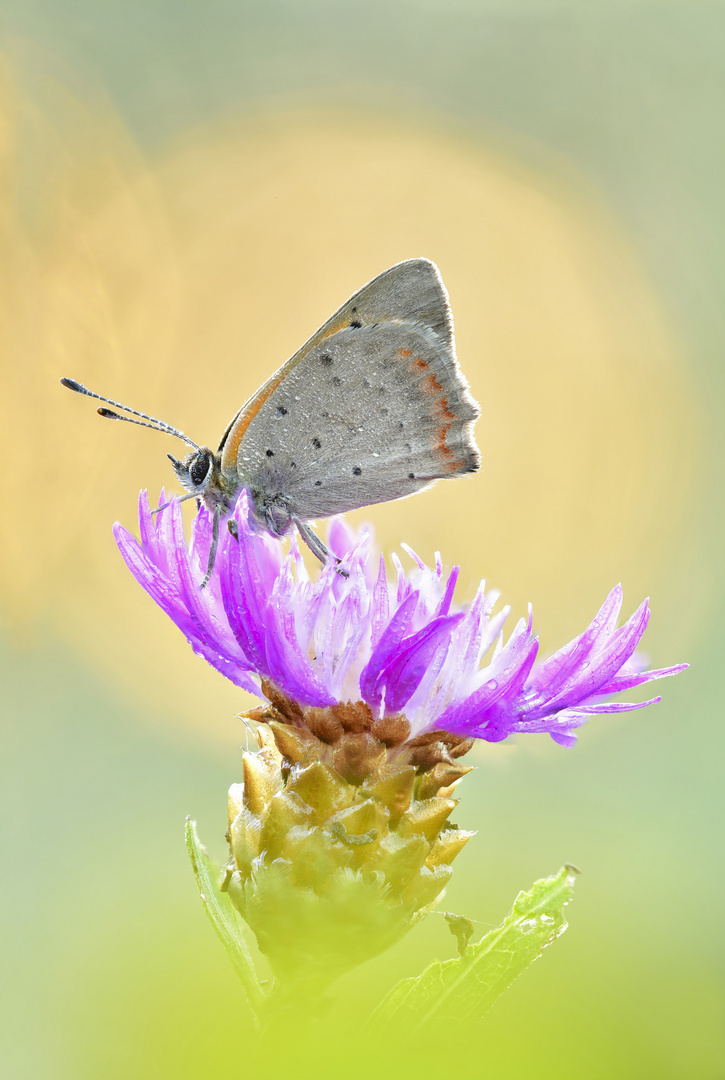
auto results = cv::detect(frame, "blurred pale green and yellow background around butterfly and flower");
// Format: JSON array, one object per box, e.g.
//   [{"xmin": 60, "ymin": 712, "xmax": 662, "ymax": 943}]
[{"xmin": 0, "ymin": 0, "xmax": 725, "ymax": 1080}]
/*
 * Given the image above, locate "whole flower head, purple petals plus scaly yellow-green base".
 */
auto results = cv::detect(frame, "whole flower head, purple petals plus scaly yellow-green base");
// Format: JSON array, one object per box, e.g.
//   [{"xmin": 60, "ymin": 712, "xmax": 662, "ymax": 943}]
[{"xmin": 116, "ymin": 494, "xmax": 681, "ymax": 986}]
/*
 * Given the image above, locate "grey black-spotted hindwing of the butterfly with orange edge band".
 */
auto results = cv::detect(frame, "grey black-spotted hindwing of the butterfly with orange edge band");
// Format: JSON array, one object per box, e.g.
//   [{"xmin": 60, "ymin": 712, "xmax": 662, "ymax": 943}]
[{"xmin": 237, "ymin": 313, "xmax": 479, "ymax": 521}]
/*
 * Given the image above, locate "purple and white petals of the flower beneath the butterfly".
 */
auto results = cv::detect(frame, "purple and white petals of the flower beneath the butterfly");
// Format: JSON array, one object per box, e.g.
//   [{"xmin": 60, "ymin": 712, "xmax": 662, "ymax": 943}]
[{"xmin": 115, "ymin": 492, "xmax": 687, "ymax": 745}]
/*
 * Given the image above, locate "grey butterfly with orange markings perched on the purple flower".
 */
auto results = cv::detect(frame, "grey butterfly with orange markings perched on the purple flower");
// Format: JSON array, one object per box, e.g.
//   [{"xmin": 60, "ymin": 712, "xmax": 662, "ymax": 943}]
[{"xmin": 61, "ymin": 258, "xmax": 481, "ymax": 589}]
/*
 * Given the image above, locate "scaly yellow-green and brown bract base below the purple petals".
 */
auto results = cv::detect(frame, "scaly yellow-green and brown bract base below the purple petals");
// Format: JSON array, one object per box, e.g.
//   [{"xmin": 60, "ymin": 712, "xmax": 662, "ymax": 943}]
[{"xmin": 223, "ymin": 710, "xmax": 473, "ymax": 986}]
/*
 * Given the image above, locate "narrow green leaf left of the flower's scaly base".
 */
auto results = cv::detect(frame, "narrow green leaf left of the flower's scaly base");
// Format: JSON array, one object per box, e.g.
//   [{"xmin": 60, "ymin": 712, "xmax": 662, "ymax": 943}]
[{"xmin": 185, "ymin": 818, "xmax": 265, "ymax": 1016}]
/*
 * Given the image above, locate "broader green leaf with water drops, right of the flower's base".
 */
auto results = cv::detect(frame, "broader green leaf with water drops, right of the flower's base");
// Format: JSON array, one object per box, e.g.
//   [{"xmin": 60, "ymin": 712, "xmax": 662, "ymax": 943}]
[{"xmin": 368, "ymin": 866, "xmax": 578, "ymax": 1039}]
